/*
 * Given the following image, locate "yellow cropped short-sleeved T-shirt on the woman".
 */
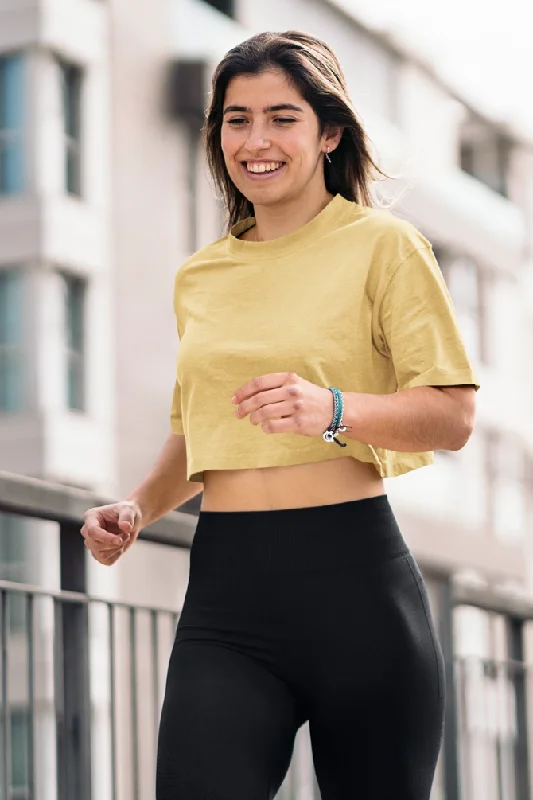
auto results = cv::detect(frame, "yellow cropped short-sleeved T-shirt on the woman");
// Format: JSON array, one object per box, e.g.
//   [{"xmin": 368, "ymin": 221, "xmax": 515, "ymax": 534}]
[{"xmin": 171, "ymin": 195, "xmax": 479, "ymax": 482}]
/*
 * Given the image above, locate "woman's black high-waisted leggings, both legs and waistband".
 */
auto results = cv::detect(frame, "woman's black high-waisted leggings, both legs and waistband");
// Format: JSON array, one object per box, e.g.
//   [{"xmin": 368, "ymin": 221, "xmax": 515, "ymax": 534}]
[{"xmin": 157, "ymin": 495, "xmax": 444, "ymax": 800}]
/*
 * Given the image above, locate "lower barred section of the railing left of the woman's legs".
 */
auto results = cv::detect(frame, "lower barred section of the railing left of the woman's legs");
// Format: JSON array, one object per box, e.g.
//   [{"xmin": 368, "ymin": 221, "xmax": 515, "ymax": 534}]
[{"xmin": 0, "ymin": 581, "xmax": 178, "ymax": 800}]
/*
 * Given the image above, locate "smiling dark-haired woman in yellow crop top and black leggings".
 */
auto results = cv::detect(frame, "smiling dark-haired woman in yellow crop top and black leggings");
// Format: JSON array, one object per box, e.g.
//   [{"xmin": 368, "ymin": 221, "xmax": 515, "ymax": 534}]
[{"xmin": 82, "ymin": 32, "xmax": 478, "ymax": 800}]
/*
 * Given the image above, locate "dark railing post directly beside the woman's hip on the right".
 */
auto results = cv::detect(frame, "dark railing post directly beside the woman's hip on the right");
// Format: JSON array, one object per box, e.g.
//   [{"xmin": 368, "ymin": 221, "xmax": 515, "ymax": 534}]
[{"xmin": 439, "ymin": 578, "xmax": 461, "ymax": 800}]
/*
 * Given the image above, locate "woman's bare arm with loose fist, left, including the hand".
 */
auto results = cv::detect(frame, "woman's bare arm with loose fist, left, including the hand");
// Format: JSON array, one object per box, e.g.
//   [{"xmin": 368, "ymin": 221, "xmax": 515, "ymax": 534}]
[{"xmin": 81, "ymin": 433, "xmax": 204, "ymax": 566}]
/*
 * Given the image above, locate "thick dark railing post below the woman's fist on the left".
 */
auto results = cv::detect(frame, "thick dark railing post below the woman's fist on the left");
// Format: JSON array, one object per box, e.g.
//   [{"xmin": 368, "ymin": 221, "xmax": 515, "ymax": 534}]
[{"xmin": 56, "ymin": 523, "xmax": 91, "ymax": 800}]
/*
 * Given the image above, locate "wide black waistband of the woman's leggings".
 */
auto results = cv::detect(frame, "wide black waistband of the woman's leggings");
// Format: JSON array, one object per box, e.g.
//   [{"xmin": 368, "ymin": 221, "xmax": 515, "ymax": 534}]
[{"xmin": 191, "ymin": 494, "xmax": 409, "ymax": 572}]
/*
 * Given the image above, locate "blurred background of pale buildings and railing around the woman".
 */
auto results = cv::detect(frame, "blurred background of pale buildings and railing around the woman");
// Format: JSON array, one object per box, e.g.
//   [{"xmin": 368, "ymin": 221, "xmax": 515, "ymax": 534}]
[{"xmin": 0, "ymin": 0, "xmax": 533, "ymax": 800}]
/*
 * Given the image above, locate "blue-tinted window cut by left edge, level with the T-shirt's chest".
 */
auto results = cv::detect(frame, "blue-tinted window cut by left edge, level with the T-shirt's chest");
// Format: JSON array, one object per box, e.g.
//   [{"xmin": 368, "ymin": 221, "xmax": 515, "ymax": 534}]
[{"xmin": 0, "ymin": 269, "xmax": 23, "ymax": 412}]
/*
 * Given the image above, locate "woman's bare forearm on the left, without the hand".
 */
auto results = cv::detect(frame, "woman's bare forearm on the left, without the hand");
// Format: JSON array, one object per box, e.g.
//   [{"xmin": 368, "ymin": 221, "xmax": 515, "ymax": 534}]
[{"xmin": 125, "ymin": 433, "xmax": 204, "ymax": 528}]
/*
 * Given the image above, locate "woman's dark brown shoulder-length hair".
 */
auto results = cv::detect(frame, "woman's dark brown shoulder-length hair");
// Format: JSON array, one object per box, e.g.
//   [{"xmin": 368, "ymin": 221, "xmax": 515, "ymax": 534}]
[{"xmin": 203, "ymin": 31, "xmax": 386, "ymax": 227}]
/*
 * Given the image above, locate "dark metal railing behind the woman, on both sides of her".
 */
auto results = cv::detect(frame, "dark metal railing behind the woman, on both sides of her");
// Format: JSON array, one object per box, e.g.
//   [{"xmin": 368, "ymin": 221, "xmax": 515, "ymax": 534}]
[{"xmin": 0, "ymin": 472, "xmax": 533, "ymax": 800}]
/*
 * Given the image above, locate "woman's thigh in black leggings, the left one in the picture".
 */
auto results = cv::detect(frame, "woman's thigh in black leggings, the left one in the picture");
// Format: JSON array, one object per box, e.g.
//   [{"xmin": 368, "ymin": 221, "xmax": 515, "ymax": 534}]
[{"xmin": 156, "ymin": 641, "xmax": 300, "ymax": 800}]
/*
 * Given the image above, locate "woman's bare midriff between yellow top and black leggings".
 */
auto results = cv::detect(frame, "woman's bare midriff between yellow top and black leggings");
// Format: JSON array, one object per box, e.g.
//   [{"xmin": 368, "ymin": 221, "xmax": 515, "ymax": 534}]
[{"xmin": 201, "ymin": 456, "xmax": 385, "ymax": 511}]
